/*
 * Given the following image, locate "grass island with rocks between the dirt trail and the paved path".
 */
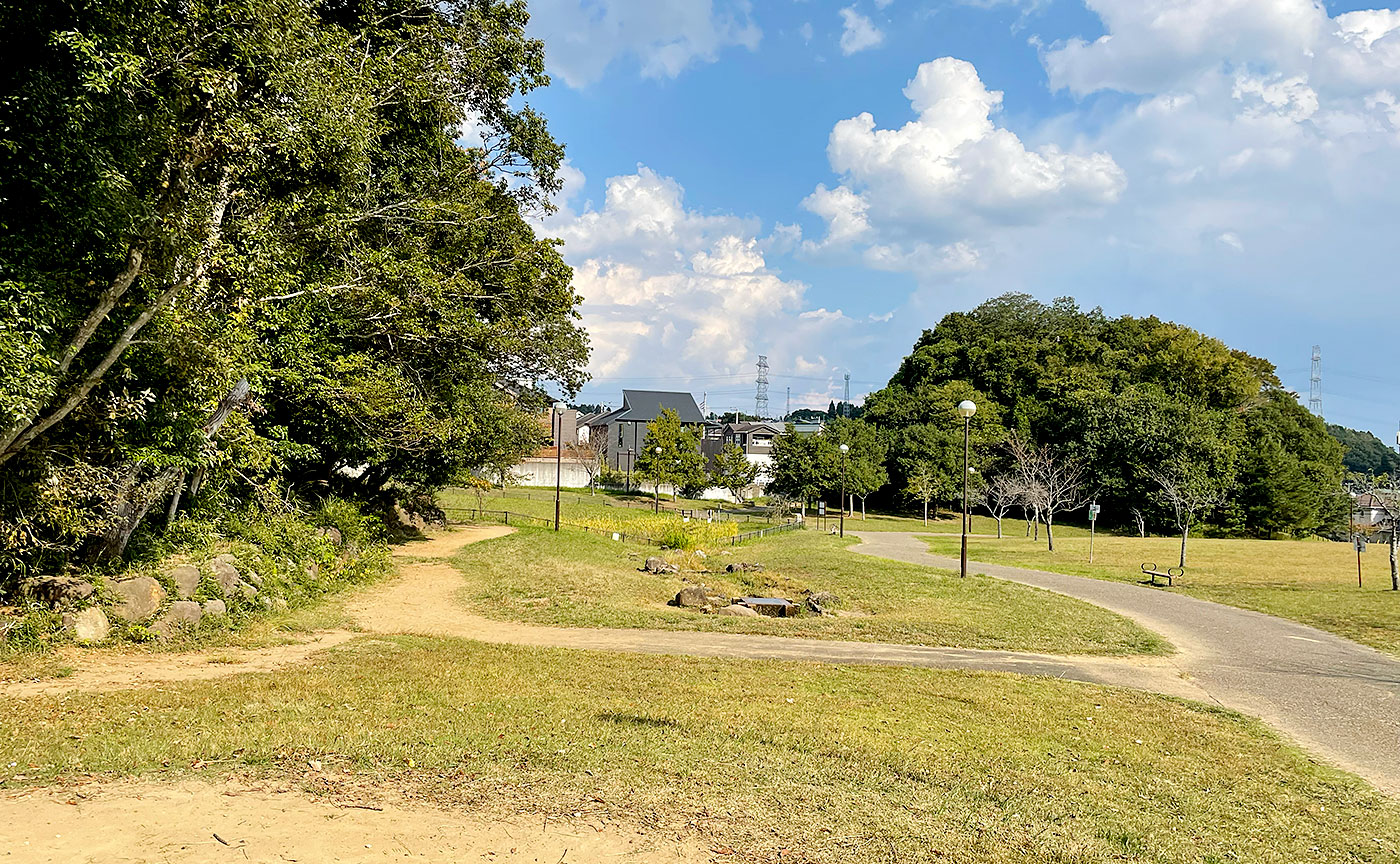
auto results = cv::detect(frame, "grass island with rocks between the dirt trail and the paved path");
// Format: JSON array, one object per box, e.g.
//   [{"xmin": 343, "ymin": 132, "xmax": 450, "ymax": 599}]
[{"xmin": 452, "ymin": 528, "xmax": 1169, "ymax": 654}]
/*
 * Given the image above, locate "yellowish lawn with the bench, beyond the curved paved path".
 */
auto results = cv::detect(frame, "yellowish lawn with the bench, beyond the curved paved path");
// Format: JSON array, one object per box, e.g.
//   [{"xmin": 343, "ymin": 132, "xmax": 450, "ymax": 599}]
[{"xmin": 928, "ymin": 535, "xmax": 1400, "ymax": 654}]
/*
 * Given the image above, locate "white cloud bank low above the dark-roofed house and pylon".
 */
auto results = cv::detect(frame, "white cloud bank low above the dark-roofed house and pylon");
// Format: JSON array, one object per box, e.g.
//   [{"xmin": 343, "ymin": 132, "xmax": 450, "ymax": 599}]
[{"xmin": 540, "ymin": 165, "xmax": 865, "ymax": 405}]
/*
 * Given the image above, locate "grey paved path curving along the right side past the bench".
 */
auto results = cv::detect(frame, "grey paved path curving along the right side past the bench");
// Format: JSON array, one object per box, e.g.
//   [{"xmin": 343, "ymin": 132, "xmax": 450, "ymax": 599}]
[{"xmin": 854, "ymin": 532, "xmax": 1400, "ymax": 793}]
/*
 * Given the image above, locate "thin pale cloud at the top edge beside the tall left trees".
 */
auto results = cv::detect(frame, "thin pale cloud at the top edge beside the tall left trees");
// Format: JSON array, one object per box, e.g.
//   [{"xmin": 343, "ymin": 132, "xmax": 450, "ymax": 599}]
[{"xmin": 529, "ymin": 0, "xmax": 763, "ymax": 88}]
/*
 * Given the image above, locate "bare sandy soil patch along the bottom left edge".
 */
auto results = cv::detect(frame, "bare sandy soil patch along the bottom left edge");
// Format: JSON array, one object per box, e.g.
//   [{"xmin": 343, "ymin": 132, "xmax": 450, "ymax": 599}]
[{"xmin": 0, "ymin": 777, "xmax": 711, "ymax": 864}]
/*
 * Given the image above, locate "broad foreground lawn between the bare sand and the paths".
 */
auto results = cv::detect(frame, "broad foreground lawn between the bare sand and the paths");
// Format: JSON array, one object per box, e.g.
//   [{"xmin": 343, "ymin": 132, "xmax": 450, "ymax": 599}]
[{"xmin": 0, "ymin": 637, "xmax": 1400, "ymax": 864}]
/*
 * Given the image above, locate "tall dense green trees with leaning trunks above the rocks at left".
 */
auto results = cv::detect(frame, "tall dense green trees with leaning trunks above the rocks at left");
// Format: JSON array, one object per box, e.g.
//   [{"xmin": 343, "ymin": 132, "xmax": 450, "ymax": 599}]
[{"xmin": 0, "ymin": 0, "xmax": 587, "ymax": 591}]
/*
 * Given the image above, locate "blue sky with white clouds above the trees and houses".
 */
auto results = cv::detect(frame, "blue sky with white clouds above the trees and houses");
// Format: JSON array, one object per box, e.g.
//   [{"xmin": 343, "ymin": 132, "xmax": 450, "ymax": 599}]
[{"xmin": 509, "ymin": 0, "xmax": 1400, "ymax": 441}]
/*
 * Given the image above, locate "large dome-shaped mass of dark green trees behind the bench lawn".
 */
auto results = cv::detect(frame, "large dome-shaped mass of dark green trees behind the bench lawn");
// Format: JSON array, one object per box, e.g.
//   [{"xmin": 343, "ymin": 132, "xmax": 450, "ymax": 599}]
[{"xmin": 864, "ymin": 294, "xmax": 1343, "ymax": 535}]
